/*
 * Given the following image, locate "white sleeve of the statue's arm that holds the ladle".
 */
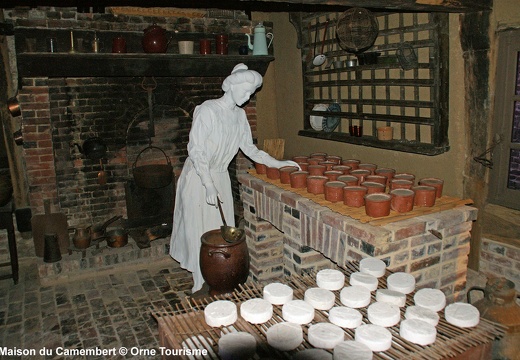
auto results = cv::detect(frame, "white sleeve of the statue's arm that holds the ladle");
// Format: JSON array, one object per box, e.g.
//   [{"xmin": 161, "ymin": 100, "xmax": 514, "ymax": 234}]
[{"xmin": 188, "ymin": 105, "xmax": 213, "ymax": 187}]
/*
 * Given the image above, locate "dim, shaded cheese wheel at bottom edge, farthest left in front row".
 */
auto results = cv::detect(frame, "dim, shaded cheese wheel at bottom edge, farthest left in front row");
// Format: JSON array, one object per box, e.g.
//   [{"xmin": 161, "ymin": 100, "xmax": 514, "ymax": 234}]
[{"xmin": 218, "ymin": 331, "xmax": 256, "ymax": 360}]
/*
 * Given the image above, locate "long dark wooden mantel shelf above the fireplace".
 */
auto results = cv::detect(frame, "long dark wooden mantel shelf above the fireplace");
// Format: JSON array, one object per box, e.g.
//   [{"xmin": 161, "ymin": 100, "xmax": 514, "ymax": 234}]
[{"xmin": 17, "ymin": 53, "xmax": 274, "ymax": 77}]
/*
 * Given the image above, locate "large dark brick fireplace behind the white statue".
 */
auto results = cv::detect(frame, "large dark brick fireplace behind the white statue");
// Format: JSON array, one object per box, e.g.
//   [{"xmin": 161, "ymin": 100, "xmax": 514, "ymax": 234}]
[{"xmin": 4, "ymin": 7, "xmax": 270, "ymax": 275}]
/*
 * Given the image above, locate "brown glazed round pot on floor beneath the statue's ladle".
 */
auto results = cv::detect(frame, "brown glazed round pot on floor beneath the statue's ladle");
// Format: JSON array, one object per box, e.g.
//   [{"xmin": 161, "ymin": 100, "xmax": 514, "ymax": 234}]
[{"xmin": 200, "ymin": 229, "xmax": 249, "ymax": 296}]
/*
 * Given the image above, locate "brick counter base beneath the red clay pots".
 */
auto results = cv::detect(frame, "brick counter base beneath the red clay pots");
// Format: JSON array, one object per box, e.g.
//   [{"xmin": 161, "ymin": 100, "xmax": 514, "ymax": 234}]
[{"xmin": 239, "ymin": 174, "xmax": 477, "ymax": 302}]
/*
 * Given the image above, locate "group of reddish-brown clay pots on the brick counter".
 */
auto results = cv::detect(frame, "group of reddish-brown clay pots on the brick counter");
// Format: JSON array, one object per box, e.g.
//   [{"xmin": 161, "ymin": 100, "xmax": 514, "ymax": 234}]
[{"xmin": 255, "ymin": 153, "xmax": 443, "ymax": 217}]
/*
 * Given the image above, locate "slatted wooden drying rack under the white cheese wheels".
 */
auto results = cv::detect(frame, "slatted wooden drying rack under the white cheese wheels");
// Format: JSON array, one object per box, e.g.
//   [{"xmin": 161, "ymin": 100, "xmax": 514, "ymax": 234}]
[{"xmin": 151, "ymin": 262, "xmax": 506, "ymax": 360}]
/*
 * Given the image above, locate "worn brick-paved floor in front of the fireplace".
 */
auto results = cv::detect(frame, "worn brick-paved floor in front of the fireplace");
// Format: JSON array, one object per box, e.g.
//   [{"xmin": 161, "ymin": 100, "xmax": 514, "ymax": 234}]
[{"xmin": 0, "ymin": 259, "xmax": 193, "ymax": 359}]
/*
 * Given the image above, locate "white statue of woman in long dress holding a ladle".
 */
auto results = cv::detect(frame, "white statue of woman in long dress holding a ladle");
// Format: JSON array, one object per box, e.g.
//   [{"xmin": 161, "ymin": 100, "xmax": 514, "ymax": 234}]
[{"xmin": 170, "ymin": 64, "xmax": 298, "ymax": 292}]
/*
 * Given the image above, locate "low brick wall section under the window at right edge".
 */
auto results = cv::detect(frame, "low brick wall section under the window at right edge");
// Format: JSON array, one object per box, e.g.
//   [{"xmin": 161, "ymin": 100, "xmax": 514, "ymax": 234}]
[{"xmin": 479, "ymin": 238, "xmax": 520, "ymax": 291}]
